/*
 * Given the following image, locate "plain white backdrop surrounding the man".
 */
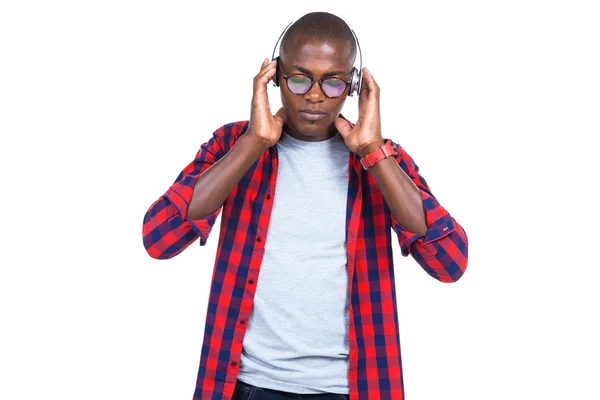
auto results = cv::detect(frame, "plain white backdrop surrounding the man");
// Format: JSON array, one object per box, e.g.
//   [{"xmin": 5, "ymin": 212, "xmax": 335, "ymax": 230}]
[{"xmin": 0, "ymin": 0, "xmax": 600, "ymax": 400}]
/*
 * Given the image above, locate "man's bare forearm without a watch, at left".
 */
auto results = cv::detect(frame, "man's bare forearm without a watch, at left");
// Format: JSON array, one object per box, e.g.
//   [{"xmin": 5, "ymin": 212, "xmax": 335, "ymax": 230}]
[{"xmin": 187, "ymin": 133, "xmax": 268, "ymax": 220}]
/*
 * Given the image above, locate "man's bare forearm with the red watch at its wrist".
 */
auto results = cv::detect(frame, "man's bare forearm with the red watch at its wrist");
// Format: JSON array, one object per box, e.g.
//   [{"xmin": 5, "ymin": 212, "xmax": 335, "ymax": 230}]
[{"xmin": 359, "ymin": 142, "xmax": 427, "ymax": 235}]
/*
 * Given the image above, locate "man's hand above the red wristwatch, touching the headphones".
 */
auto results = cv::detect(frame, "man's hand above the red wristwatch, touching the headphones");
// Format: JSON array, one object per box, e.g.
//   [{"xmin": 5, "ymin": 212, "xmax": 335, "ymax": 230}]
[{"xmin": 334, "ymin": 67, "xmax": 385, "ymax": 157}]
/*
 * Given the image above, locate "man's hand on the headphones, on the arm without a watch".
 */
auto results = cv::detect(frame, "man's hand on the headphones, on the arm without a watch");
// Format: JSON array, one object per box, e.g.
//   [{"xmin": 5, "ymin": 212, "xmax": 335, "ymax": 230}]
[{"xmin": 247, "ymin": 58, "xmax": 285, "ymax": 148}]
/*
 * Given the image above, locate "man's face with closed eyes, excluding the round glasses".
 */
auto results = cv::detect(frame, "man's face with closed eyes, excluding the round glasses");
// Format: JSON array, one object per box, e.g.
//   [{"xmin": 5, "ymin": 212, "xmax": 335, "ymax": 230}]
[{"xmin": 279, "ymin": 35, "xmax": 353, "ymax": 142}]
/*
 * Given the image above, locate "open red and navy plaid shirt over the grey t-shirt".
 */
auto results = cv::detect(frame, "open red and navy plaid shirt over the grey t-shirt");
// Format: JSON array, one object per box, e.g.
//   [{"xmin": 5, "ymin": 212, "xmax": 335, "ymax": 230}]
[{"xmin": 143, "ymin": 114, "xmax": 468, "ymax": 400}]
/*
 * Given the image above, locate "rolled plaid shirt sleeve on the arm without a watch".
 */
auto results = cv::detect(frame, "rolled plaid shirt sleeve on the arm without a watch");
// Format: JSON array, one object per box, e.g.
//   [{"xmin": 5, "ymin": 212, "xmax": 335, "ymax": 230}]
[{"xmin": 142, "ymin": 127, "xmax": 224, "ymax": 259}]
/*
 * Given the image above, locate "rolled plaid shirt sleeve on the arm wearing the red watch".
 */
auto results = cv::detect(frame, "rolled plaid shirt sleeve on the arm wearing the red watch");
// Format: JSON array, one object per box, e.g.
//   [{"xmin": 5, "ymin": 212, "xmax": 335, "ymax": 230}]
[{"xmin": 390, "ymin": 140, "xmax": 468, "ymax": 282}]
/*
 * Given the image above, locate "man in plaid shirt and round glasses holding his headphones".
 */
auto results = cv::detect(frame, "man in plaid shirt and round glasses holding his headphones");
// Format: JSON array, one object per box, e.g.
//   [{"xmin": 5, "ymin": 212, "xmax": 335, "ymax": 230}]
[{"xmin": 143, "ymin": 12, "xmax": 468, "ymax": 400}]
